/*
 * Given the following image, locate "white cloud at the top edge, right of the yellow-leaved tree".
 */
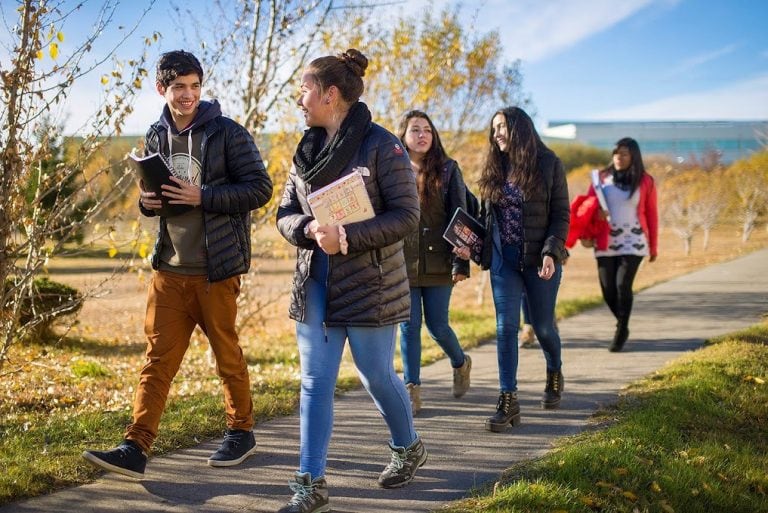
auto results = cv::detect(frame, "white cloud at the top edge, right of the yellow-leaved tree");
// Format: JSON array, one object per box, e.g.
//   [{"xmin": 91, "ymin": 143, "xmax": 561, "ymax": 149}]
[{"xmin": 477, "ymin": 0, "xmax": 670, "ymax": 62}]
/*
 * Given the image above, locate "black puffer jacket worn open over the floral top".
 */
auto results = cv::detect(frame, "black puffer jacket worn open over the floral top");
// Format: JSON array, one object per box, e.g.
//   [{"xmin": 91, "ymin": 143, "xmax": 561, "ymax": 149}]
[{"xmin": 480, "ymin": 149, "xmax": 571, "ymax": 269}]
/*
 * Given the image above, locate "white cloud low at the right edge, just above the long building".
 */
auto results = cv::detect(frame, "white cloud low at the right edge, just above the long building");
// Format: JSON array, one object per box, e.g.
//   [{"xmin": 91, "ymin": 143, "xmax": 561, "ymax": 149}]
[{"xmin": 590, "ymin": 73, "xmax": 768, "ymax": 121}]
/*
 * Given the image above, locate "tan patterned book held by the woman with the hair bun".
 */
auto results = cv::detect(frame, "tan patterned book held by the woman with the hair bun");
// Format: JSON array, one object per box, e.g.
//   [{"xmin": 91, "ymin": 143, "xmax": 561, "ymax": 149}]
[{"xmin": 307, "ymin": 171, "xmax": 376, "ymax": 226}]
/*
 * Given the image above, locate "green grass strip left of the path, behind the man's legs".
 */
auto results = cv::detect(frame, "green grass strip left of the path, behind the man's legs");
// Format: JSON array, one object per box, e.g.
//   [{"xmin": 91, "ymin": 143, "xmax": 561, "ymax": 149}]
[{"xmin": 0, "ymin": 381, "xmax": 298, "ymax": 504}]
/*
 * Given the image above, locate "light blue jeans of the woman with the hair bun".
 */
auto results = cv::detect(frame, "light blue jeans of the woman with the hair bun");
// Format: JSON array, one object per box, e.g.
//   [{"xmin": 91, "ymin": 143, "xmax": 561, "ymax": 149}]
[{"xmin": 296, "ymin": 278, "xmax": 417, "ymax": 479}]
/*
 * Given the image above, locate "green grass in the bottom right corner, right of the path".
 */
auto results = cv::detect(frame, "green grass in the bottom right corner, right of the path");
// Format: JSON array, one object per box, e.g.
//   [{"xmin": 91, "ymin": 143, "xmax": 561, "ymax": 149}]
[{"xmin": 440, "ymin": 323, "xmax": 768, "ymax": 513}]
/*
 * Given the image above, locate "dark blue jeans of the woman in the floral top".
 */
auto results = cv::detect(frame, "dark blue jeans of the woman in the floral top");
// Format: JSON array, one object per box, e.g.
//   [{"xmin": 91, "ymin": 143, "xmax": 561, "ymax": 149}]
[{"xmin": 491, "ymin": 245, "xmax": 562, "ymax": 392}]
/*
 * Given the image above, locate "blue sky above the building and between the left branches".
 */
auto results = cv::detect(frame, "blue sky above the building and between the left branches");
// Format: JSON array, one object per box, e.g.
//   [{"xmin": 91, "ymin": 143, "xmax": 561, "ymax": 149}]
[{"xmin": 7, "ymin": 0, "xmax": 768, "ymax": 133}]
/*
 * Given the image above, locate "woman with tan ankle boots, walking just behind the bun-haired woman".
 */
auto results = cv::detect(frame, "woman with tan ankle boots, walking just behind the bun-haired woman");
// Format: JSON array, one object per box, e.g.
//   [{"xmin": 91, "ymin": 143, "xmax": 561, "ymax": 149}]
[{"xmin": 398, "ymin": 110, "xmax": 472, "ymax": 415}]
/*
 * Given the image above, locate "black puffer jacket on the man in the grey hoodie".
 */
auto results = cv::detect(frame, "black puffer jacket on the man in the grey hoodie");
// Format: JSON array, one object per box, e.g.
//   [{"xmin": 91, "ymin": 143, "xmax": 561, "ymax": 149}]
[{"xmin": 139, "ymin": 116, "xmax": 272, "ymax": 282}]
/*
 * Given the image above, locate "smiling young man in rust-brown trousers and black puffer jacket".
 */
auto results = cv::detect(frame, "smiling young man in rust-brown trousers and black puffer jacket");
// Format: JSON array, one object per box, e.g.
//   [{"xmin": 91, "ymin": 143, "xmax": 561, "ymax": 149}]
[{"xmin": 83, "ymin": 51, "xmax": 272, "ymax": 479}]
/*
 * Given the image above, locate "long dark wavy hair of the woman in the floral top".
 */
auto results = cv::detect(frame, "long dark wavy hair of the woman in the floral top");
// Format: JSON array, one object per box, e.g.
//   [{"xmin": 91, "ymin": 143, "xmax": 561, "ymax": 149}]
[{"xmin": 478, "ymin": 107, "xmax": 549, "ymax": 203}]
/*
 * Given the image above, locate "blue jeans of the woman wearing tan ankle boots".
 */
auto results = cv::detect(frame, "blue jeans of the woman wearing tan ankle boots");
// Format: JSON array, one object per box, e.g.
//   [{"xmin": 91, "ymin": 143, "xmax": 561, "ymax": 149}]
[{"xmin": 400, "ymin": 285, "xmax": 464, "ymax": 385}]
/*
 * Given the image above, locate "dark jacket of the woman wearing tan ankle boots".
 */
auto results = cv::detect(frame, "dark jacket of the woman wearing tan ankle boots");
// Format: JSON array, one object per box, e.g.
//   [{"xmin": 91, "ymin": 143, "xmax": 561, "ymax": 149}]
[{"xmin": 404, "ymin": 159, "xmax": 469, "ymax": 287}]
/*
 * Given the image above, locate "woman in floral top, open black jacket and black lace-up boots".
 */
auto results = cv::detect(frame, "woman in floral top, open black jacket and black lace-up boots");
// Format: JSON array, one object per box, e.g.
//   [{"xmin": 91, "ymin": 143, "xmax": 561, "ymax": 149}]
[{"xmin": 460, "ymin": 107, "xmax": 570, "ymax": 432}]
